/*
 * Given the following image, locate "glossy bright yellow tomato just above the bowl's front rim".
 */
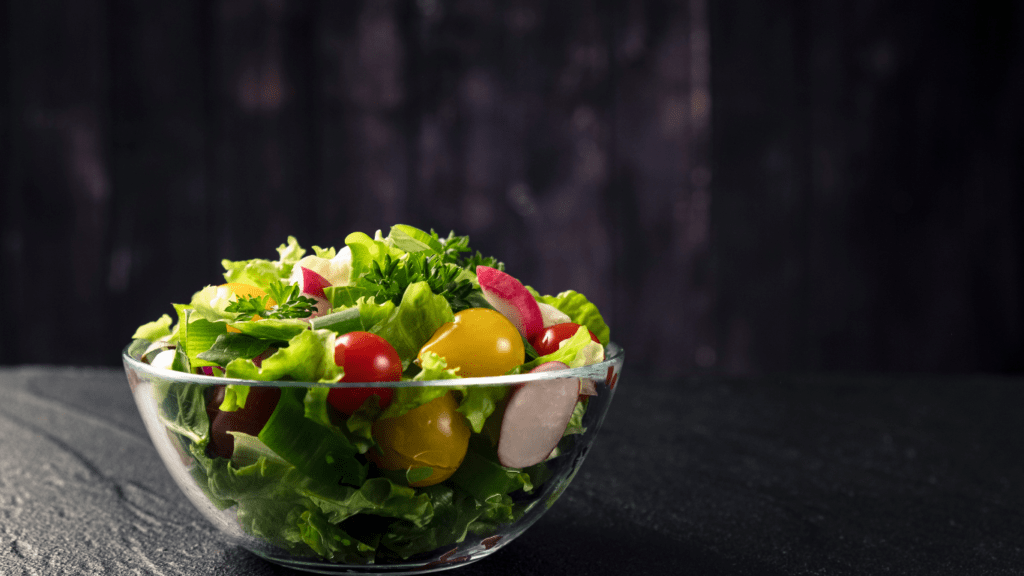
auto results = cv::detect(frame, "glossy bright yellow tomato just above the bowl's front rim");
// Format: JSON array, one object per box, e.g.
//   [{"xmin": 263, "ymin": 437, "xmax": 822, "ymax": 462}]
[{"xmin": 419, "ymin": 308, "xmax": 526, "ymax": 378}]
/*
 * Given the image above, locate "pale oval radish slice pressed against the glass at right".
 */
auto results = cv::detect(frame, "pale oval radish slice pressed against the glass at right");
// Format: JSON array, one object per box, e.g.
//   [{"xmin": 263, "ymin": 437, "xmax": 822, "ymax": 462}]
[{"xmin": 498, "ymin": 362, "xmax": 580, "ymax": 468}]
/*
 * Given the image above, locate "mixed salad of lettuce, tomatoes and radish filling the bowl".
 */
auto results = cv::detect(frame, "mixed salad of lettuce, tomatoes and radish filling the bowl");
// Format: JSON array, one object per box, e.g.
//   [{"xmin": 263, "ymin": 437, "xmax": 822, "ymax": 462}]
[{"xmin": 133, "ymin": 224, "xmax": 609, "ymax": 564}]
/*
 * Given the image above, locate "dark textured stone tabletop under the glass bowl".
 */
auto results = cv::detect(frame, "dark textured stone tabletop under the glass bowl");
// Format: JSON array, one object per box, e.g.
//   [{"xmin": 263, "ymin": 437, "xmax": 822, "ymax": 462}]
[{"xmin": 0, "ymin": 366, "xmax": 1024, "ymax": 576}]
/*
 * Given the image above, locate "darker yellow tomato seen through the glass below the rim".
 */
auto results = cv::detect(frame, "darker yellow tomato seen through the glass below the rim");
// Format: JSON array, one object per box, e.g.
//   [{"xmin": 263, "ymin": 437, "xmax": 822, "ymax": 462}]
[{"xmin": 367, "ymin": 393, "xmax": 469, "ymax": 487}]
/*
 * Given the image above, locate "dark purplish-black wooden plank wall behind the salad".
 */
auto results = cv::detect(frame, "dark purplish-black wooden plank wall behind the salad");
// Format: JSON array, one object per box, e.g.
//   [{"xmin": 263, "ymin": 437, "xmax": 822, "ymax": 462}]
[{"xmin": 0, "ymin": 0, "xmax": 1024, "ymax": 374}]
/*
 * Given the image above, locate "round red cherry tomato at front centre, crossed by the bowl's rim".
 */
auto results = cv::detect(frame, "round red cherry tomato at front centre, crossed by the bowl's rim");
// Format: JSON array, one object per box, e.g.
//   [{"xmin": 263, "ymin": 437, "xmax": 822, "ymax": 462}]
[{"xmin": 327, "ymin": 332, "xmax": 401, "ymax": 415}]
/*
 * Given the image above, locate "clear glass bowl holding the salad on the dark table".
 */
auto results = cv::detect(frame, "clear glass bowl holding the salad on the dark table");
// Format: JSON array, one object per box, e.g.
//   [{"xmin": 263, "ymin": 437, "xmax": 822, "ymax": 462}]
[{"xmin": 122, "ymin": 340, "xmax": 624, "ymax": 574}]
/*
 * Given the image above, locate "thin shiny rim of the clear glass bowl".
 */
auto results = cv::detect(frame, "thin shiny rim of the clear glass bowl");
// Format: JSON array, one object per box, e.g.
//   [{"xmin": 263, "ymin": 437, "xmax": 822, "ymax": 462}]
[{"xmin": 128, "ymin": 339, "xmax": 626, "ymax": 388}]
